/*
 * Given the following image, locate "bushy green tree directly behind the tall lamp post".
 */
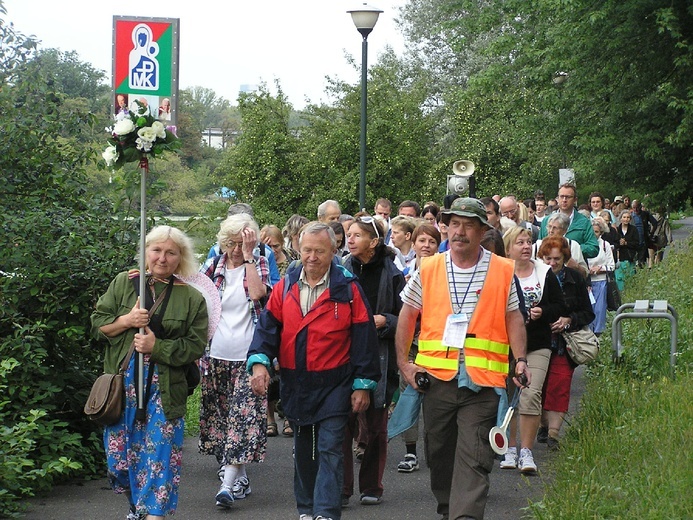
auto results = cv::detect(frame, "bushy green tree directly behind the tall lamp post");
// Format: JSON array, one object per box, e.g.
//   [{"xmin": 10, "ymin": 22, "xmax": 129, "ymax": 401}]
[{"xmin": 300, "ymin": 50, "xmax": 438, "ymax": 215}]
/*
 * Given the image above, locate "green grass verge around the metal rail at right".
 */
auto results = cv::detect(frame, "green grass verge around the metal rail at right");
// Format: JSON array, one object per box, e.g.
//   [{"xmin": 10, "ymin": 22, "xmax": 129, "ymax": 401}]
[{"xmin": 529, "ymin": 238, "xmax": 693, "ymax": 520}]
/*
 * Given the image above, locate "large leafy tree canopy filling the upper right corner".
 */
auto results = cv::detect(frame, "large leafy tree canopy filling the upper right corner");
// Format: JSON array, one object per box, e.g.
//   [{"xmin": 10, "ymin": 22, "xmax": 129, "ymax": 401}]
[{"xmin": 394, "ymin": 0, "xmax": 693, "ymax": 204}]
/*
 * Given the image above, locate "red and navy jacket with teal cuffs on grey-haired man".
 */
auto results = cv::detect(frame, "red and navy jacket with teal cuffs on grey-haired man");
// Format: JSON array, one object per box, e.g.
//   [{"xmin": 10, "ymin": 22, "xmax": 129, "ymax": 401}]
[{"xmin": 248, "ymin": 260, "xmax": 380, "ymax": 426}]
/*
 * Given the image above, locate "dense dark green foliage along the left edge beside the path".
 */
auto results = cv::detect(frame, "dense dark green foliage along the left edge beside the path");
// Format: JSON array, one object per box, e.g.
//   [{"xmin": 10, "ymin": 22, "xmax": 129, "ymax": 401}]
[{"xmin": 0, "ymin": 4, "xmax": 137, "ymax": 516}]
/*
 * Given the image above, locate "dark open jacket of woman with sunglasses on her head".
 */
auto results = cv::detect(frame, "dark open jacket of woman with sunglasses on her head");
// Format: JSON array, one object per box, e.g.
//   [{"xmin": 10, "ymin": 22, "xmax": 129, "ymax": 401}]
[{"xmin": 344, "ymin": 245, "xmax": 405, "ymax": 408}]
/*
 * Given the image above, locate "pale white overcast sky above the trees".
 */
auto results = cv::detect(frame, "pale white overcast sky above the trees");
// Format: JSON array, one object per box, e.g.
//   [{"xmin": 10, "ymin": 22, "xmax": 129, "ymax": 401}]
[{"xmin": 4, "ymin": 0, "xmax": 406, "ymax": 109}]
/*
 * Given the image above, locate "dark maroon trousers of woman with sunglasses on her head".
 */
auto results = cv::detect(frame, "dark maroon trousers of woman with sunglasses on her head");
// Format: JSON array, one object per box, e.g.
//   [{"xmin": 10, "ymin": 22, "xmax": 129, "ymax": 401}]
[{"xmin": 342, "ymin": 402, "xmax": 387, "ymax": 497}]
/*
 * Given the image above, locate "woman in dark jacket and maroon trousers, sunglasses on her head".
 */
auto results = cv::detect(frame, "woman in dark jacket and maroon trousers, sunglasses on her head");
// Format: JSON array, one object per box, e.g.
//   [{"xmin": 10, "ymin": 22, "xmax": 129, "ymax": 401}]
[{"xmin": 343, "ymin": 216, "xmax": 404, "ymax": 505}]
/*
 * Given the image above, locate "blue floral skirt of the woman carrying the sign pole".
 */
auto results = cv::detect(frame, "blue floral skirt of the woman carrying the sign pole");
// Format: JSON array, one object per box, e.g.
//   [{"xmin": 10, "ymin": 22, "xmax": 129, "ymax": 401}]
[{"xmin": 104, "ymin": 353, "xmax": 184, "ymax": 516}]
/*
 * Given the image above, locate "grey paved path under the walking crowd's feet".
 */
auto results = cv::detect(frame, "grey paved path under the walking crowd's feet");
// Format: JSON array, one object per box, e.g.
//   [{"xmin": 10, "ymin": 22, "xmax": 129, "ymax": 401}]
[{"xmin": 25, "ymin": 368, "xmax": 583, "ymax": 520}]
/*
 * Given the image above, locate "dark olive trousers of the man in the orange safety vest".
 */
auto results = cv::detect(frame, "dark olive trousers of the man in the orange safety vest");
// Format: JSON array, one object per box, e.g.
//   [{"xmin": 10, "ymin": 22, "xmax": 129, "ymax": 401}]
[{"xmin": 423, "ymin": 378, "xmax": 499, "ymax": 520}]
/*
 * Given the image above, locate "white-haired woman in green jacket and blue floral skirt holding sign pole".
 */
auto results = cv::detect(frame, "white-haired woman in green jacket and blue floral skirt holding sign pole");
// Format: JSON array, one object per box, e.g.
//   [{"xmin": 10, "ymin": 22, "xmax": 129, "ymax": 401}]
[{"xmin": 91, "ymin": 226, "xmax": 208, "ymax": 520}]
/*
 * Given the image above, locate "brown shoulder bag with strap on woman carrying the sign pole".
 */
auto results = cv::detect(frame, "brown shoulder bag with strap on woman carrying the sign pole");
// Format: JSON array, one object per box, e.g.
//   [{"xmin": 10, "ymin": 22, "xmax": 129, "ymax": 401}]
[{"xmin": 84, "ymin": 286, "xmax": 168, "ymax": 426}]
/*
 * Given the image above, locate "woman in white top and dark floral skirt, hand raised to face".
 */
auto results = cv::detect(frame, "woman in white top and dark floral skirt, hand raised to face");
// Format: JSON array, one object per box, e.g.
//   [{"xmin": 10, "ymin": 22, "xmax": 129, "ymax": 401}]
[{"xmin": 199, "ymin": 213, "xmax": 271, "ymax": 509}]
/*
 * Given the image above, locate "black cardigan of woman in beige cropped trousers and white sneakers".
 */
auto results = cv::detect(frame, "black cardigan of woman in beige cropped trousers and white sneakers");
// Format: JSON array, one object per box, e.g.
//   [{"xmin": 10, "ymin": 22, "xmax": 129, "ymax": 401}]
[{"xmin": 526, "ymin": 260, "xmax": 568, "ymax": 352}]
